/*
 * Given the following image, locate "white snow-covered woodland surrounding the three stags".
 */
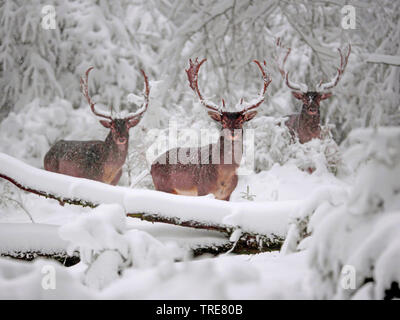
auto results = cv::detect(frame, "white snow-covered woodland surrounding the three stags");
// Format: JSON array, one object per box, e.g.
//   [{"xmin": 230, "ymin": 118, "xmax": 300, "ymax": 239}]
[{"xmin": 0, "ymin": 0, "xmax": 400, "ymax": 299}]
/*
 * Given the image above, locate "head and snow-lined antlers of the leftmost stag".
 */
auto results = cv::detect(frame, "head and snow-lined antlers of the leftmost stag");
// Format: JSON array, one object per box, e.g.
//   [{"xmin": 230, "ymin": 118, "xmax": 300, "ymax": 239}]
[{"xmin": 80, "ymin": 67, "xmax": 150, "ymax": 146}]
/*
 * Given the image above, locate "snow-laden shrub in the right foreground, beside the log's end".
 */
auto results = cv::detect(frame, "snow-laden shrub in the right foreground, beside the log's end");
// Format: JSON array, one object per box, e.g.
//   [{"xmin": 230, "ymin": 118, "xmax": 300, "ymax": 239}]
[{"xmin": 300, "ymin": 127, "xmax": 400, "ymax": 299}]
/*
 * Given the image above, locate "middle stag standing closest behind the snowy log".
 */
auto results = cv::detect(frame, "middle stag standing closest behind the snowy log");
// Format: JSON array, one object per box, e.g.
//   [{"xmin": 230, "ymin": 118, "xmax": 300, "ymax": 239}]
[{"xmin": 151, "ymin": 58, "xmax": 271, "ymax": 201}]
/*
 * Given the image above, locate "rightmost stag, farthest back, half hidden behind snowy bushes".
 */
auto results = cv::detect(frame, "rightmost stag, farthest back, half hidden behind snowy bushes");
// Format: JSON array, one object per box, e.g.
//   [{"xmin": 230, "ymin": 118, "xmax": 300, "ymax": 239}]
[{"xmin": 277, "ymin": 39, "xmax": 351, "ymax": 143}]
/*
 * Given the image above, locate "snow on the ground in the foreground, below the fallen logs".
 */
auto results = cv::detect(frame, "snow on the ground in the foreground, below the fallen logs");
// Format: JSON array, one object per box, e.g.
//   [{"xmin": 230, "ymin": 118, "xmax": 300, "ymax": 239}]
[{"xmin": 0, "ymin": 252, "xmax": 311, "ymax": 299}]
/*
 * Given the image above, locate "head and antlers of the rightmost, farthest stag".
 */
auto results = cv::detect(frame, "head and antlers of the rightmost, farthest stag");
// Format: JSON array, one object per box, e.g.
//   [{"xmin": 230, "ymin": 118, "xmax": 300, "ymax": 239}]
[{"xmin": 276, "ymin": 38, "xmax": 351, "ymax": 116}]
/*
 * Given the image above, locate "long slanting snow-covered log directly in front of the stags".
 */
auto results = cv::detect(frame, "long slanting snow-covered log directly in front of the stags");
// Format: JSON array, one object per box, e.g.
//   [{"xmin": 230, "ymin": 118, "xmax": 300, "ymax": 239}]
[{"xmin": 0, "ymin": 154, "xmax": 296, "ymax": 249}]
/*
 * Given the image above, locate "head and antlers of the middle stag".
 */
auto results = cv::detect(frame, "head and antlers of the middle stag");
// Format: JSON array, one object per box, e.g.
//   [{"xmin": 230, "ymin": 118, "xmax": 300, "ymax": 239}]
[{"xmin": 186, "ymin": 58, "xmax": 271, "ymax": 141}]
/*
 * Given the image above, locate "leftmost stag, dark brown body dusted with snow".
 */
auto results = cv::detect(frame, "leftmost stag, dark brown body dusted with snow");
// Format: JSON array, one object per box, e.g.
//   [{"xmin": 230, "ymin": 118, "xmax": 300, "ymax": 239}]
[{"xmin": 44, "ymin": 67, "xmax": 150, "ymax": 185}]
